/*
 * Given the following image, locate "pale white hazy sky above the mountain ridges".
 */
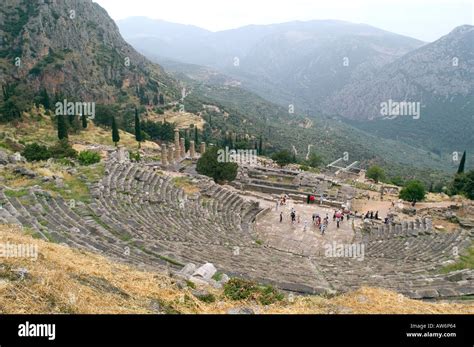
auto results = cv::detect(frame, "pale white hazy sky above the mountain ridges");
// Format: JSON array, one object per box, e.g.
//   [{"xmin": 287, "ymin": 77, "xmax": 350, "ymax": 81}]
[{"xmin": 94, "ymin": 0, "xmax": 474, "ymax": 41}]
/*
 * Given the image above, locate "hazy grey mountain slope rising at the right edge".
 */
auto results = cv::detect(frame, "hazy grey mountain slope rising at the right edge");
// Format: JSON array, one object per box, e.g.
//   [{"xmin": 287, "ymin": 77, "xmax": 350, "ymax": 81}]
[{"xmin": 330, "ymin": 25, "xmax": 474, "ymax": 153}]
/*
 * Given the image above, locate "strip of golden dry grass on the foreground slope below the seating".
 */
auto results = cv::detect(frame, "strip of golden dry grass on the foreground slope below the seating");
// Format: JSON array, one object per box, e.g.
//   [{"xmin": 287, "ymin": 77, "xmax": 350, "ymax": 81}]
[{"xmin": 0, "ymin": 226, "xmax": 474, "ymax": 314}]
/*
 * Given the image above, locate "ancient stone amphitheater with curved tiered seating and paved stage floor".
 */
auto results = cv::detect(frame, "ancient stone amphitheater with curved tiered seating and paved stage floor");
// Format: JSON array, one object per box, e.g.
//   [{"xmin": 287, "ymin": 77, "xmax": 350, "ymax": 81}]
[{"xmin": 0, "ymin": 148, "xmax": 474, "ymax": 299}]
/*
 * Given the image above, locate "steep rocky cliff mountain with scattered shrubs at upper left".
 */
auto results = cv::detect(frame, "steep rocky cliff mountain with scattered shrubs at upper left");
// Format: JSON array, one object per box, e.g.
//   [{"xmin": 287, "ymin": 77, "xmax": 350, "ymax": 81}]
[{"xmin": 0, "ymin": 0, "xmax": 177, "ymax": 103}]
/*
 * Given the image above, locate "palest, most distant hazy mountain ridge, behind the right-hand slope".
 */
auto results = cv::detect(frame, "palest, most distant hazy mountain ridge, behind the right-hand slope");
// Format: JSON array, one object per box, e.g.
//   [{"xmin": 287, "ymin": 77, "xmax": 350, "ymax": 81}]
[{"xmin": 118, "ymin": 18, "xmax": 423, "ymax": 110}]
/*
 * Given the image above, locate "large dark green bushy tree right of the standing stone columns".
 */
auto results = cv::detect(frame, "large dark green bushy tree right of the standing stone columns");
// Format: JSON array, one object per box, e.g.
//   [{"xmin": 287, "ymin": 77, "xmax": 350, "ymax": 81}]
[{"xmin": 196, "ymin": 147, "xmax": 238, "ymax": 183}]
